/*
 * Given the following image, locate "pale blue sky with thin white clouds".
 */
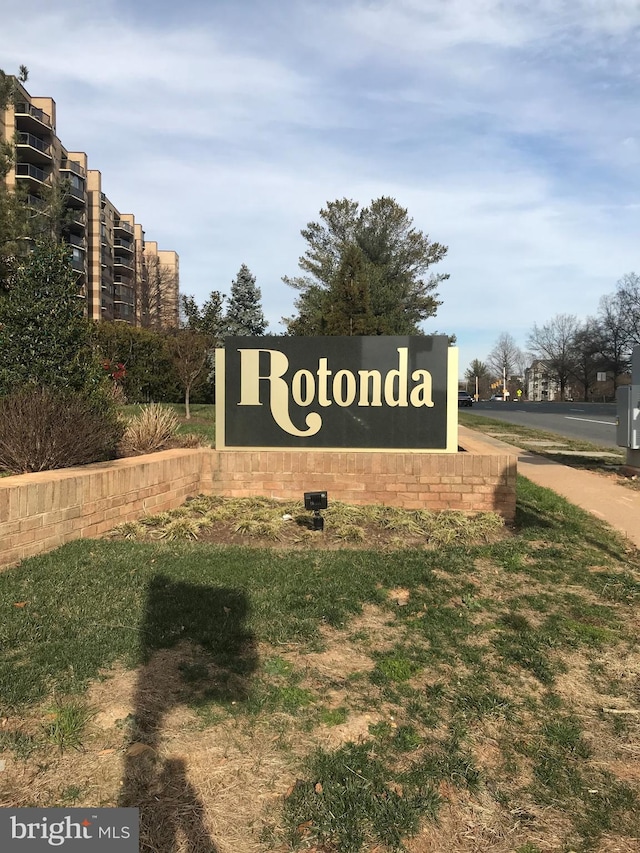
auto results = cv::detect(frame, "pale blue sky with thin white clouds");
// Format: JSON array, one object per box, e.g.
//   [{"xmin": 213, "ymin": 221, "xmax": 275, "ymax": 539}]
[{"xmin": 0, "ymin": 0, "xmax": 640, "ymax": 374}]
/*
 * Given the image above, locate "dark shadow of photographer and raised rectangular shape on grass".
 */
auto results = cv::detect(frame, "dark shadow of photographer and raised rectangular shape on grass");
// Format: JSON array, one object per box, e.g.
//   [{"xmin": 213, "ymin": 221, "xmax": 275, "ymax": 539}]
[{"xmin": 119, "ymin": 575, "xmax": 257, "ymax": 853}]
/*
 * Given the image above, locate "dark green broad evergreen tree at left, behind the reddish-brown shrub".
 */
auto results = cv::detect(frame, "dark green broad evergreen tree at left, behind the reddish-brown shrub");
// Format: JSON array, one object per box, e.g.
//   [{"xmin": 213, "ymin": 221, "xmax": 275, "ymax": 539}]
[{"xmin": 0, "ymin": 241, "xmax": 102, "ymax": 396}]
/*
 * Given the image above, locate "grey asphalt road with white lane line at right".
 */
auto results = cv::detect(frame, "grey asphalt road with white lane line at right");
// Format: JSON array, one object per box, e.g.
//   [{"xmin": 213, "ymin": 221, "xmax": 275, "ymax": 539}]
[{"xmin": 461, "ymin": 402, "xmax": 617, "ymax": 447}]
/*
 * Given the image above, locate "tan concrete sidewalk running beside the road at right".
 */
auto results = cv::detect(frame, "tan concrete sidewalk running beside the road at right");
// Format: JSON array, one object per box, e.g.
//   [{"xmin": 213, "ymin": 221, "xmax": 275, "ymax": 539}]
[{"xmin": 459, "ymin": 426, "xmax": 640, "ymax": 548}]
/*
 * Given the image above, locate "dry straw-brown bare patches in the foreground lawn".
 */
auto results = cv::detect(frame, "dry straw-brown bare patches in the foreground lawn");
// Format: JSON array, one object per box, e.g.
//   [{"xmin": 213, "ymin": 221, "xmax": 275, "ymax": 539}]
[{"xmin": 0, "ymin": 596, "xmax": 640, "ymax": 853}]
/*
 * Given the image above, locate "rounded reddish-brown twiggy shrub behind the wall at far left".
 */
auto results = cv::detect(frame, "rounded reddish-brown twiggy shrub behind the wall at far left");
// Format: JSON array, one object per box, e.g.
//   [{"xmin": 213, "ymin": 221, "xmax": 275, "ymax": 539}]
[{"xmin": 0, "ymin": 388, "xmax": 124, "ymax": 474}]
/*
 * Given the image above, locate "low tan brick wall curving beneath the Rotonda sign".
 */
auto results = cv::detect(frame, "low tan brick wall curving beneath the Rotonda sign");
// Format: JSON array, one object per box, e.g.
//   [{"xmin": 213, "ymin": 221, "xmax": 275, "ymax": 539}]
[{"xmin": 0, "ymin": 428, "xmax": 516, "ymax": 566}]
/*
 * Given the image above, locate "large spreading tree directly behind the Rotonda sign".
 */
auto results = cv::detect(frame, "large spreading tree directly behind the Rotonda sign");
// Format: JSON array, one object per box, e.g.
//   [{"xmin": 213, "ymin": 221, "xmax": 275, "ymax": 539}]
[{"xmin": 283, "ymin": 196, "xmax": 449, "ymax": 335}]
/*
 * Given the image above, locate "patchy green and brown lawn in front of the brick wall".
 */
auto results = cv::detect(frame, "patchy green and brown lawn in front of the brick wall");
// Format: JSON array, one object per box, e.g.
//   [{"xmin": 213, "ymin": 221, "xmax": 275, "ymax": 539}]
[{"xmin": 0, "ymin": 478, "xmax": 640, "ymax": 853}]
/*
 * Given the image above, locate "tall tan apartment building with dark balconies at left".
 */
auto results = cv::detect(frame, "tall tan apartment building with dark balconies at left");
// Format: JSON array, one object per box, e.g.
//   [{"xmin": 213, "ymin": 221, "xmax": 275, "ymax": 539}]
[{"xmin": 0, "ymin": 81, "xmax": 179, "ymax": 328}]
